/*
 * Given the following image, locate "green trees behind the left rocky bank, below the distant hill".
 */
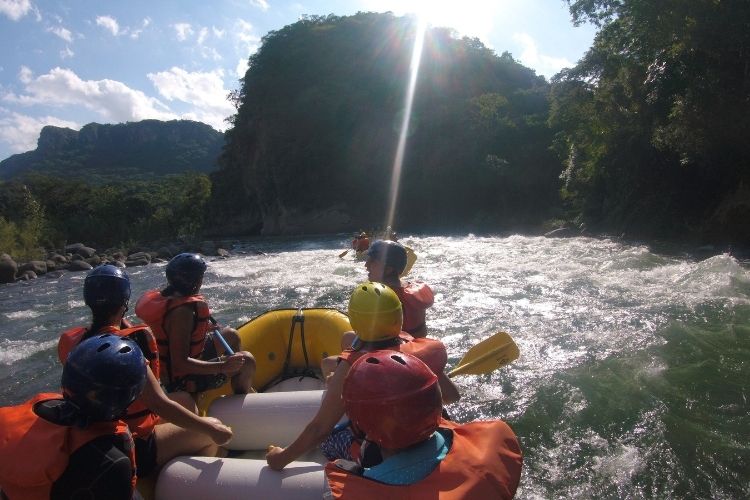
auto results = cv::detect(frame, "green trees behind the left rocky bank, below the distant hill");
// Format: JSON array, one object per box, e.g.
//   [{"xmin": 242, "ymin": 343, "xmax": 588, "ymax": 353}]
[{"xmin": 0, "ymin": 173, "xmax": 211, "ymax": 258}]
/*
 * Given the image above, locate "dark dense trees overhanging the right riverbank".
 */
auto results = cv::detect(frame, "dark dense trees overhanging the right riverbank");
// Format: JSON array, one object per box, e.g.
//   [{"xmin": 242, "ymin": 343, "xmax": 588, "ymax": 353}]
[{"xmin": 551, "ymin": 0, "xmax": 750, "ymax": 244}]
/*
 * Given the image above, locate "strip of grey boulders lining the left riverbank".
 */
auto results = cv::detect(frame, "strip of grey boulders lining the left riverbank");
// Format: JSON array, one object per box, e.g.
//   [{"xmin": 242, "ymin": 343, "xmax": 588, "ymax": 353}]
[{"xmin": 0, "ymin": 241, "xmax": 235, "ymax": 284}]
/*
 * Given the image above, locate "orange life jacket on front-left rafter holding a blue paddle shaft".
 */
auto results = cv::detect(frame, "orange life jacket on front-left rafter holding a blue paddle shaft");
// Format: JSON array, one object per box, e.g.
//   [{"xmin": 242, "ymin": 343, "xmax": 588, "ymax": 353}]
[{"xmin": 135, "ymin": 290, "xmax": 215, "ymax": 384}]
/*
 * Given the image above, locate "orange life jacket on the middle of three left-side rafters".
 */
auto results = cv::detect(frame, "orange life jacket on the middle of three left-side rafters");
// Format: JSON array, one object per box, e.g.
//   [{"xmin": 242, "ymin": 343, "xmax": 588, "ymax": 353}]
[{"xmin": 57, "ymin": 325, "xmax": 159, "ymax": 439}]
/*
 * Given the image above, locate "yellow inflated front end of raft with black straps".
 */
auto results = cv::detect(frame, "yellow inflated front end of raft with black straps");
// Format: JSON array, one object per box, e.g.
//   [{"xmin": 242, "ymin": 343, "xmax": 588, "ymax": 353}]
[{"xmin": 196, "ymin": 308, "xmax": 352, "ymax": 415}]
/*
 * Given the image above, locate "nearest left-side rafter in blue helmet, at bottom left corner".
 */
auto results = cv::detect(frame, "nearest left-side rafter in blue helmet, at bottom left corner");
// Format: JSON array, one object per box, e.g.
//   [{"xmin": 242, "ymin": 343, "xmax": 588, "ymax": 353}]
[{"xmin": 0, "ymin": 334, "xmax": 147, "ymax": 500}]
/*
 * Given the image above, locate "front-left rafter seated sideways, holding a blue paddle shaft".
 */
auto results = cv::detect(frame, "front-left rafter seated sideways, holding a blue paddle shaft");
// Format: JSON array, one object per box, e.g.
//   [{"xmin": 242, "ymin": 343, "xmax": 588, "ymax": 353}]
[{"xmin": 135, "ymin": 253, "xmax": 255, "ymax": 394}]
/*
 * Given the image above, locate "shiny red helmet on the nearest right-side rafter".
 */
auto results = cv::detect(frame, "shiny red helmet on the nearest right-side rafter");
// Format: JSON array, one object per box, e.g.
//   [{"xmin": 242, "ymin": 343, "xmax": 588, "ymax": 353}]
[{"xmin": 342, "ymin": 350, "xmax": 443, "ymax": 449}]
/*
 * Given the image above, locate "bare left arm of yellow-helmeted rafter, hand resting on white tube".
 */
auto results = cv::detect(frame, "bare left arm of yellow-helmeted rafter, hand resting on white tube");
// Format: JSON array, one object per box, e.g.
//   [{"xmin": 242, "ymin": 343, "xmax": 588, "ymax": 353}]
[{"xmin": 266, "ymin": 362, "xmax": 349, "ymax": 470}]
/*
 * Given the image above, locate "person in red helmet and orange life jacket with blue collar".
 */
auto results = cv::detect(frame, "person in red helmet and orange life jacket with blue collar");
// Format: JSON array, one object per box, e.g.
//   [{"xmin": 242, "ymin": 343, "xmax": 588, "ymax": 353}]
[{"xmin": 324, "ymin": 351, "xmax": 523, "ymax": 500}]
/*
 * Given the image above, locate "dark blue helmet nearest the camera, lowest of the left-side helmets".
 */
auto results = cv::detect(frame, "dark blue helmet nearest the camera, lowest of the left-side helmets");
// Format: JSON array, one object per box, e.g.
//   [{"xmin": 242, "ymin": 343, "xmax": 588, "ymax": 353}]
[{"xmin": 62, "ymin": 333, "xmax": 147, "ymax": 422}]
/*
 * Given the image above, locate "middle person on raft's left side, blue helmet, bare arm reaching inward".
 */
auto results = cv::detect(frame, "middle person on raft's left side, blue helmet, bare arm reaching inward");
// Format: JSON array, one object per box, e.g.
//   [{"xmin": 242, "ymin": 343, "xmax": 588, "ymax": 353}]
[{"xmin": 57, "ymin": 264, "xmax": 232, "ymax": 477}]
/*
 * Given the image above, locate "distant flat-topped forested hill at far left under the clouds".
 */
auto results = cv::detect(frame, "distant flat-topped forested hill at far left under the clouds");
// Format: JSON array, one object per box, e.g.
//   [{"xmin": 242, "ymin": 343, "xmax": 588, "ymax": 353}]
[{"xmin": 0, "ymin": 120, "xmax": 224, "ymax": 183}]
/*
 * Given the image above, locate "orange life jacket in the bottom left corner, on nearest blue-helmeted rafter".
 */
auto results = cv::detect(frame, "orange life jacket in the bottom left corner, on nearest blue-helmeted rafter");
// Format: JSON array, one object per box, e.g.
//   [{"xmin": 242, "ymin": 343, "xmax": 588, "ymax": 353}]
[{"xmin": 0, "ymin": 394, "xmax": 136, "ymax": 500}]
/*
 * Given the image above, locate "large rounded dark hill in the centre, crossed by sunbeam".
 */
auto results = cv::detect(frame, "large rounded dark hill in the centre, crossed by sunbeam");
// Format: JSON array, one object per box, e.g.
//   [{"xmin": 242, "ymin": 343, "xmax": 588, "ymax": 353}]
[{"xmin": 211, "ymin": 13, "xmax": 560, "ymax": 234}]
